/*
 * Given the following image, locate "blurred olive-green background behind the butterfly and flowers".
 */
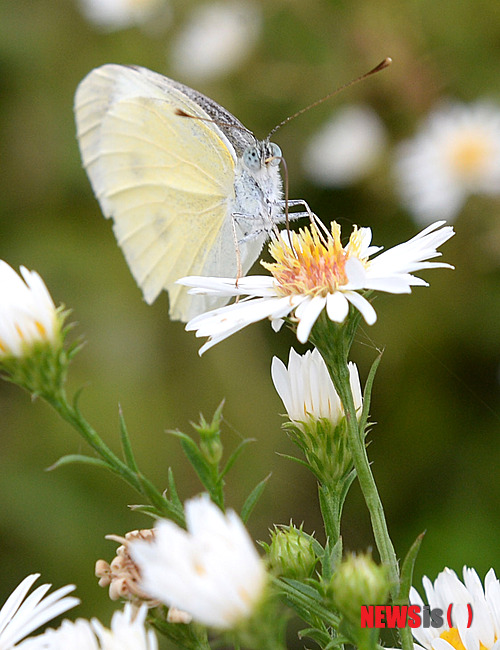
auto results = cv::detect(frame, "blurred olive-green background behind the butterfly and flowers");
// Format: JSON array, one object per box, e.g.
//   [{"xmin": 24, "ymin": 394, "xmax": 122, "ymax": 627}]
[{"xmin": 0, "ymin": 0, "xmax": 500, "ymax": 647}]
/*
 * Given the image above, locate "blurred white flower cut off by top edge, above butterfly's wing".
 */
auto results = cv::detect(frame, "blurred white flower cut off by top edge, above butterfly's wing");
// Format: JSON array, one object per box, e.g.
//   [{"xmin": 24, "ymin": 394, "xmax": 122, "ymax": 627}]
[{"xmin": 80, "ymin": 0, "xmax": 169, "ymax": 31}]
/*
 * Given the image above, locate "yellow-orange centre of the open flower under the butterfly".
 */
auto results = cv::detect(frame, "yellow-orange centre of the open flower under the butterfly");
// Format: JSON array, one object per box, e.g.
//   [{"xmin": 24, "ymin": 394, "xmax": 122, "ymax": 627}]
[{"xmin": 261, "ymin": 221, "xmax": 367, "ymax": 296}]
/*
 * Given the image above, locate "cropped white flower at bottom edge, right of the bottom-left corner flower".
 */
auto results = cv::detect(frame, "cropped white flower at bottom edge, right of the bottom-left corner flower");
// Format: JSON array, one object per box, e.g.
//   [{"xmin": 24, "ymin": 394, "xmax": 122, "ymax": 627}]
[{"xmin": 19, "ymin": 603, "xmax": 158, "ymax": 650}]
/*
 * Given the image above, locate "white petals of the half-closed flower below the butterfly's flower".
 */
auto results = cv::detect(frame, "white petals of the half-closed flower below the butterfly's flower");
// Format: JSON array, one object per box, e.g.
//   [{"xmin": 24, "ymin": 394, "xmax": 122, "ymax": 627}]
[{"xmin": 271, "ymin": 348, "xmax": 363, "ymax": 426}]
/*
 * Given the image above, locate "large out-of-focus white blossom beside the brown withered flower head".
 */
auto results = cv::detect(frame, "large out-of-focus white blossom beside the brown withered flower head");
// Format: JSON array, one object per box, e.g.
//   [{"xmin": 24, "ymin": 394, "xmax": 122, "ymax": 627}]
[{"xmin": 129, "ymin": 494, "xmax": 266, "ymax": 629}]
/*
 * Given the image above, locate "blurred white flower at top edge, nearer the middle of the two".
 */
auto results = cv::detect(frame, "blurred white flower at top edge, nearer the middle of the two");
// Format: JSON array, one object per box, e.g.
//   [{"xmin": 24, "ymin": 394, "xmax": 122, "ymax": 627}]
[{"xmin": 170, "ymin": 0, "xmax": 261, "ymax": 81}]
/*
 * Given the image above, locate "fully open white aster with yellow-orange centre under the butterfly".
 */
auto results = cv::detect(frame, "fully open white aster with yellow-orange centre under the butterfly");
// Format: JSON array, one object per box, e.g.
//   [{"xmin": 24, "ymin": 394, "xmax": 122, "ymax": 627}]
[{"xmin": 178, "ymin": 221, "xmax": 454, "ymax": 354}]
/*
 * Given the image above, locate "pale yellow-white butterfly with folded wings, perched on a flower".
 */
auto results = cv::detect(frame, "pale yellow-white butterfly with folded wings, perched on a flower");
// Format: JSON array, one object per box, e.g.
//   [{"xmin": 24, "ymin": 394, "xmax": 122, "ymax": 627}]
[{"xmin": 75, "ymin": 64, "xmax": 308, "ymax": 321}]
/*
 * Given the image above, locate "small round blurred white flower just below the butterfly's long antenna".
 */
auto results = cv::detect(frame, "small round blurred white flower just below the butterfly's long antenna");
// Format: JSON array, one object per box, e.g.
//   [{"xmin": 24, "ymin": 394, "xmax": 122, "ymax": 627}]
[{"xmin": 303, "ymin": 105, "xmax": 387, "ymax": 187}]
